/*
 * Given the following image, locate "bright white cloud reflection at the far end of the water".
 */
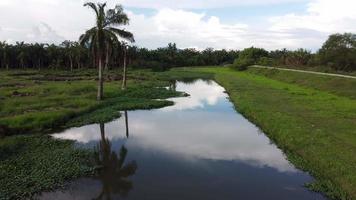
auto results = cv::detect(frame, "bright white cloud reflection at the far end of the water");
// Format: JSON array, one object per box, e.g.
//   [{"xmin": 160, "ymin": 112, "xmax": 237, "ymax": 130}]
[{"xmin": 161, "ymin": 80, "xmax": 226, "ymax": 111}]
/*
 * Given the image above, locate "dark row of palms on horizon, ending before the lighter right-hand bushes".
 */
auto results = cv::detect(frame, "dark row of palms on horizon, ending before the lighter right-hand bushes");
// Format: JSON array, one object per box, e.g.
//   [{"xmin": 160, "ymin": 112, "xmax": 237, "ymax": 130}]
[{"xmin": 0, "ymin": 41, "xmax": 239, "ymax": 70}]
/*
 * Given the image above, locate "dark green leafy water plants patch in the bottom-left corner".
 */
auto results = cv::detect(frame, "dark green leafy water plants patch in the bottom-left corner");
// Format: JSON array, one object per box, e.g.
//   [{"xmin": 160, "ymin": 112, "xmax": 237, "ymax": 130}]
[{"xmin": 0, "ymin": 135, "xmax": 94, "ymax": 199}]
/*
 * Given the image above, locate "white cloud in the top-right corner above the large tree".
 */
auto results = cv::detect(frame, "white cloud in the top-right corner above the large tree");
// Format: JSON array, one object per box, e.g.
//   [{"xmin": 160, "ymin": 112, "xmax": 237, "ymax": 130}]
[{"xmin": 269, "ymin": 0, "xmax": 356, "ymax": 48}]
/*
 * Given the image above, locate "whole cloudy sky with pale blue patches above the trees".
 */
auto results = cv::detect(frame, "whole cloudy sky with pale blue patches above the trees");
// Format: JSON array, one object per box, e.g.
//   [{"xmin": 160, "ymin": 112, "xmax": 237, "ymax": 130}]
[{"xmin": 0, "ymin": 0, "xmax": 356, "ymax": 50}]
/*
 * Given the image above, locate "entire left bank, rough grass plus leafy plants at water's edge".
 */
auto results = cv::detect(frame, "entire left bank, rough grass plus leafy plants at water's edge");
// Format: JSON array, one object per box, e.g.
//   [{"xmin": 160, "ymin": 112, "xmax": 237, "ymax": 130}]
[{"xmin": 0, "ymin": 68, "xmax": 211, "ymax": 199}]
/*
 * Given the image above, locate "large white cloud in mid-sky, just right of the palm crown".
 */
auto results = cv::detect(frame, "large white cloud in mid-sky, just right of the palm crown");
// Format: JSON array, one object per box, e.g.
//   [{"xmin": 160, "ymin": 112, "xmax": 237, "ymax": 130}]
[{"xmin": 129, "ymin": 9, "xmax": 248, "ymax": 48}]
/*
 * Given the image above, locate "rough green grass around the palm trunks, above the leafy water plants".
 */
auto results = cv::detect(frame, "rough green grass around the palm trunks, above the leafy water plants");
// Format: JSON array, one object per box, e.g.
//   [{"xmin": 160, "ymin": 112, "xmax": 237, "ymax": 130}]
[{"xmin": 0, "ymin": 71, "xmax": 181, "ymax": 134}]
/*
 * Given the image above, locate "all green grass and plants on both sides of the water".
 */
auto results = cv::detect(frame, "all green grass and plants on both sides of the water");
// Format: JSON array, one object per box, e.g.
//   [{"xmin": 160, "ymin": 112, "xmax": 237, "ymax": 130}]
[{"xmin": 0, "ymin": 67, "xmax": 356, "ymax": 199}]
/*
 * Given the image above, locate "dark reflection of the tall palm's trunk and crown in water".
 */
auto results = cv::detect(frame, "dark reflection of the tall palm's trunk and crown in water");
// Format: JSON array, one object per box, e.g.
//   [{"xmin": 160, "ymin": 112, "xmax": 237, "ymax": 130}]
[{"xmin": 95, "ymin": 124, "xmax": 137, "ymax": 199}]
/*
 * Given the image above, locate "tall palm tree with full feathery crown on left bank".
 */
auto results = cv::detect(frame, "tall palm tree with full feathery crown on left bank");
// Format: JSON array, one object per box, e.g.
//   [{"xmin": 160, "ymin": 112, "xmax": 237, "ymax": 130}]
[{"xmin": 79, "ymin": 2, "xmax": 134, "ymax": 100}]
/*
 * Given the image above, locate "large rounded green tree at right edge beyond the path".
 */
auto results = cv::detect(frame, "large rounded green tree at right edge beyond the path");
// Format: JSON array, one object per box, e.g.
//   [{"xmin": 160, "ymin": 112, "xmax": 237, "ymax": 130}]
[{"xmin": 319, "ymin": 33, "xmax": 356, "ymax": 71}]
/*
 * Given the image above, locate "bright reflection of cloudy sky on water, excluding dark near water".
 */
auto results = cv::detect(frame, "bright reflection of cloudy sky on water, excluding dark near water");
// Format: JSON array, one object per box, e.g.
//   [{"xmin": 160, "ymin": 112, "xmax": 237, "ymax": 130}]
[{"xmin": 54, "ymin": 80, "xmax": 296, "ymax": 172}]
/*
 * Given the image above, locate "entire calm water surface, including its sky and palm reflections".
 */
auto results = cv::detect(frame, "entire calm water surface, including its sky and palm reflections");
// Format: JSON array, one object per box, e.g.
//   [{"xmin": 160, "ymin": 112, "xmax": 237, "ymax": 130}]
[{"xmin": 40, "ymin": 80, "xmax": 323, "ymax": 200}]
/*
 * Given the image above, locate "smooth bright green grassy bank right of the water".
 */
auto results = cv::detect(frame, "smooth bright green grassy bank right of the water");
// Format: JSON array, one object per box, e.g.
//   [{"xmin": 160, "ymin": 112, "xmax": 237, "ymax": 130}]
[{"xmin": 182, "ymin": 68, "xmax": 356, "ymax": 199}]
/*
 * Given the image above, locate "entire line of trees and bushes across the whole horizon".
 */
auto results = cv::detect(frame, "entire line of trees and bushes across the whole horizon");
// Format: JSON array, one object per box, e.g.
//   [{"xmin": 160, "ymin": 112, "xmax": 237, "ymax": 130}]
[{"xmin": 0, "ymin": 33, "xmax": 356, "ymax": 71}]
